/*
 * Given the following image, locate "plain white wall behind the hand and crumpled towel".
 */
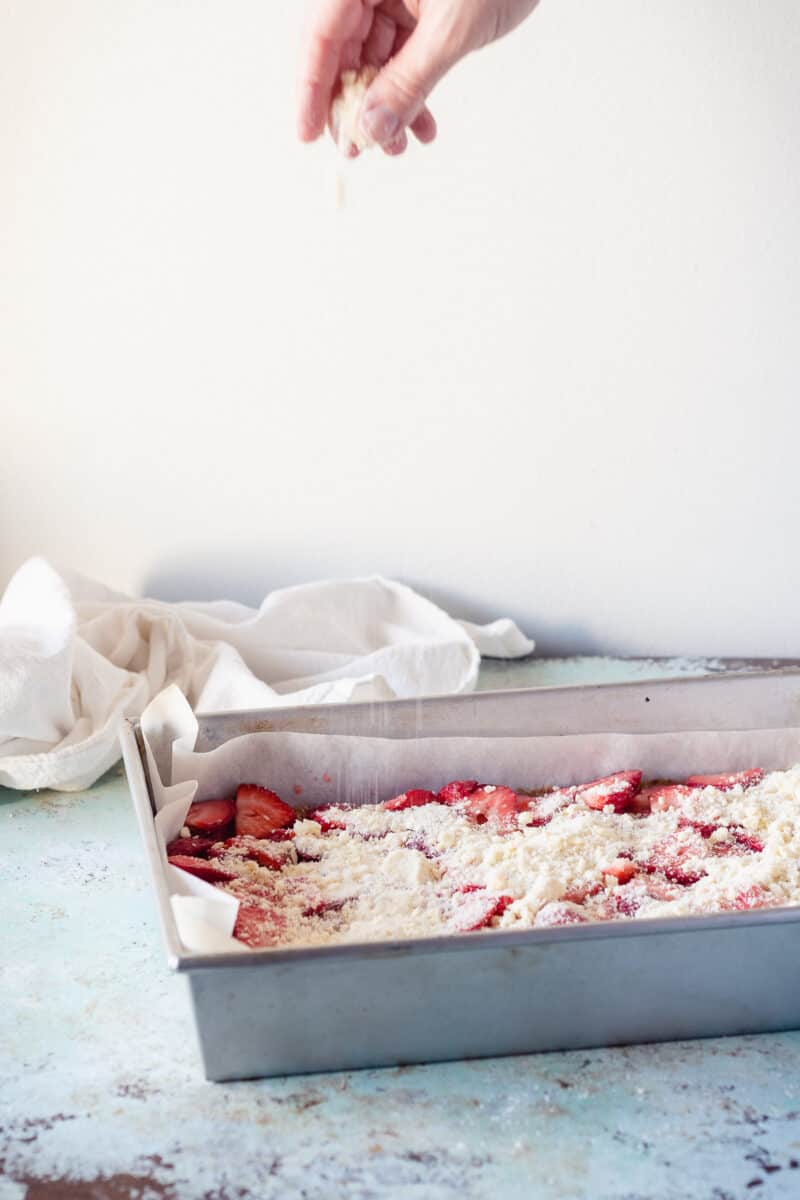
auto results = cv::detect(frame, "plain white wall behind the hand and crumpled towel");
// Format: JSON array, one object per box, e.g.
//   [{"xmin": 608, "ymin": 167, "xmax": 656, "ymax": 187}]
[{"xmin": 0, "ymin": 0, "xmax": 800, "ymax": 655}]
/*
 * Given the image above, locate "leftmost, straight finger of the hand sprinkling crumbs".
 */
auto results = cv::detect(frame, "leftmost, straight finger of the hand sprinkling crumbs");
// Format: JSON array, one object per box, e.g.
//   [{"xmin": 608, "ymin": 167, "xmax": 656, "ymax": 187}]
[{"xmin": 297, "ymin": 0, "xmax": 371, "ymax": 142}]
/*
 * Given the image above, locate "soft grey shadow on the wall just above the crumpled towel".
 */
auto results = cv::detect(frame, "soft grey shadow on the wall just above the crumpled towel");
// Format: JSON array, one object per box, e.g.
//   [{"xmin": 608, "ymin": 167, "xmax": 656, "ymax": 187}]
[{"xmin": 142, "ymin": 550, "xmax": 608, "ymax": 655}]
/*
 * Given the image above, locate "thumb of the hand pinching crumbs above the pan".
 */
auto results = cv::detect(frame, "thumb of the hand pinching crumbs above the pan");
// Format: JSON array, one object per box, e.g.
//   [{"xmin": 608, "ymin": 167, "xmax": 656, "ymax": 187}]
[{"xmin": 361, "ymin": 18, "xmax": 459, "ymax": 146}]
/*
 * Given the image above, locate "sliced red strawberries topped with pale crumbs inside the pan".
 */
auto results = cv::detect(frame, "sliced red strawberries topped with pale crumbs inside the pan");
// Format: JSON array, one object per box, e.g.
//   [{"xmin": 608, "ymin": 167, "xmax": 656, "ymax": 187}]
[{"xmin": 167, "ymin": 766, "xmax": 800, "ymax": 948}]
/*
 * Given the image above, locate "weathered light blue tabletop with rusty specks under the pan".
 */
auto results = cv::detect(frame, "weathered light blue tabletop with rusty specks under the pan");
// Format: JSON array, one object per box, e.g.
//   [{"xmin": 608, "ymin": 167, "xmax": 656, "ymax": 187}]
[{"xmin": 0, "ymin": 659, "xmax": 800, "ymax": 1200}]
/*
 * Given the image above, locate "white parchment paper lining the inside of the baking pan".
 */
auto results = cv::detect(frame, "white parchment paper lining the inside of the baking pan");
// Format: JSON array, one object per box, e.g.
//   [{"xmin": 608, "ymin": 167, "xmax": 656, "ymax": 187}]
[{"xmin": 142, "ymin": 688, "xmax": 800, "ymax": 953}]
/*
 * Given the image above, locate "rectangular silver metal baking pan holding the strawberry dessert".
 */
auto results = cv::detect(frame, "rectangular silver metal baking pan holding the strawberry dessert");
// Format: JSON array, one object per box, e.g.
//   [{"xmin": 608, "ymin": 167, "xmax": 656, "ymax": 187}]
[{"xmin": 117, "ymin": 670, "xmax": 800, "ymax": 1080}]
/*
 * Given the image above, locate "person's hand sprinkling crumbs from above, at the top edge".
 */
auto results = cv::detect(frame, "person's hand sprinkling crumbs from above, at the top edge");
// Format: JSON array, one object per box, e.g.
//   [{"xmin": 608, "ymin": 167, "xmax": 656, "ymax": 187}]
[{"xmin": 297, "ymin": 0, "xmax": 539, "ymax": 154}]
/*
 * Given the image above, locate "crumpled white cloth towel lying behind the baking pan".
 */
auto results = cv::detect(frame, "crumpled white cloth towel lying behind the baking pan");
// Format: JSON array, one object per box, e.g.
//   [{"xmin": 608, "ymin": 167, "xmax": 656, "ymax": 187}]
[{"xmin": 0, "ymin": 558, "xmax": 534, "ymax": 792}]
